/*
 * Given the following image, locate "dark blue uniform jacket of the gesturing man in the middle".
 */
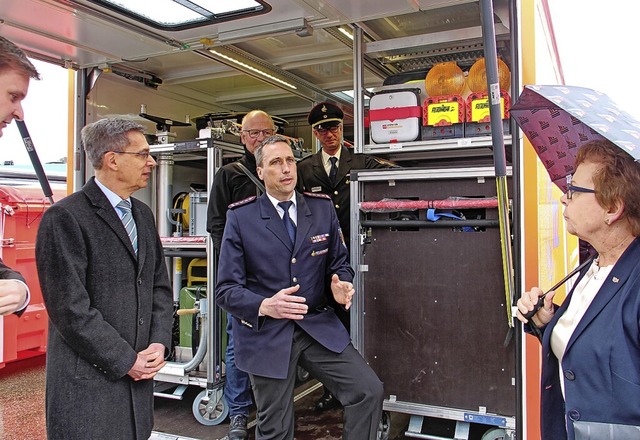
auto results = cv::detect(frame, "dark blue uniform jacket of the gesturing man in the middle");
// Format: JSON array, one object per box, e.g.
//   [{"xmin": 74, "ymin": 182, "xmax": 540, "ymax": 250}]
[{"xmin": 216, "ymin": 193, "xmax": 353, "ymax": 379}]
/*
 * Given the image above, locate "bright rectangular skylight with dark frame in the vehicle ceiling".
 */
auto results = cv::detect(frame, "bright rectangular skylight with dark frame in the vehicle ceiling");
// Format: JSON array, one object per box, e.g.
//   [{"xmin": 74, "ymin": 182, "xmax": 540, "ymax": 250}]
[{"xmin": 89, "ymin": 0, "xmax": 270, "ymax": 29}]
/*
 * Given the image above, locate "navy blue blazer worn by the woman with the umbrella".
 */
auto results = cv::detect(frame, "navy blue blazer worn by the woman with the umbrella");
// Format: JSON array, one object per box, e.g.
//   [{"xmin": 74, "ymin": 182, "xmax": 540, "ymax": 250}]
[{"xmin": 541, "ymin": 238, "xmax": 640, "ymax": 440}]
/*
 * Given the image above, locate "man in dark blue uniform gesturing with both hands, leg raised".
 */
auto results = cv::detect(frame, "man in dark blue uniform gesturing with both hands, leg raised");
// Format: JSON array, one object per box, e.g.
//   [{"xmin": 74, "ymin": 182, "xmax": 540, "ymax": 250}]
[{"xmin": 216, "ymin": 136, "xmax": 384, "ymax": 440}]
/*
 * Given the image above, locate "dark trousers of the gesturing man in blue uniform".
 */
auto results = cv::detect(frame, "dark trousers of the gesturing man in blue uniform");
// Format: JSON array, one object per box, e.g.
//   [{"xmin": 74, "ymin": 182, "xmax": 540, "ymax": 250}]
[{"xmin": 250, "ymin": 326, "xmax": 384, "ymax": 440}]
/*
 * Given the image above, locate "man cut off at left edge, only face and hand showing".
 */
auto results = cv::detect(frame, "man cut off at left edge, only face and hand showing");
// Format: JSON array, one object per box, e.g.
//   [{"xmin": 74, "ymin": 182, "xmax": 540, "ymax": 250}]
[{"xmin": 0, "ymin": 37, "xmax": 40, "ymax": 315}]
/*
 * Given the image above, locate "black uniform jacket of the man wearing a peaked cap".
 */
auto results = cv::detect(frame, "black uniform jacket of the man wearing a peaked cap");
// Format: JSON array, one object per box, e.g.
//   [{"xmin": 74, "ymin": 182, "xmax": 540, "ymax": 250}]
[{"xmin": 298, "ymin": 146, "xmax": 395, "ymax": 246}]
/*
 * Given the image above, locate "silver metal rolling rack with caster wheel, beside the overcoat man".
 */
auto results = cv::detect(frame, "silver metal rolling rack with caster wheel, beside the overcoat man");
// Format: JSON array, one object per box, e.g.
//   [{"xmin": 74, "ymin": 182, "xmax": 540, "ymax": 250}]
[{"xmin": 150, "ymin": 136, "xmax": 244, "ymax": 425}]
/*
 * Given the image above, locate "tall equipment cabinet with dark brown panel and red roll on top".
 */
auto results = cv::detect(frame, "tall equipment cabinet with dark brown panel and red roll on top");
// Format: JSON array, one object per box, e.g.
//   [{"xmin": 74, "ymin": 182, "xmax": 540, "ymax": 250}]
[{"xmin": 351, "ymin": 167, "xmax": 517, "ymax": 439}]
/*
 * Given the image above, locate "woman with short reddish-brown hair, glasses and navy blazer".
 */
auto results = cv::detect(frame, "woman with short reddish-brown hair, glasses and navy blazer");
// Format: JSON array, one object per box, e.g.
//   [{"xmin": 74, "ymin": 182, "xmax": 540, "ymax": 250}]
[{"xmin": 517, "ymin": 141, "xmax": 640, "ymax": 440}]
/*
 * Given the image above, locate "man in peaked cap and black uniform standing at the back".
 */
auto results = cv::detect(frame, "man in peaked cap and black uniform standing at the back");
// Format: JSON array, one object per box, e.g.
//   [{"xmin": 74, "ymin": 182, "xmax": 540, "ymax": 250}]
[{"xmin": 297, "ymin": 102, "xmax": 395, "ymax": 411}]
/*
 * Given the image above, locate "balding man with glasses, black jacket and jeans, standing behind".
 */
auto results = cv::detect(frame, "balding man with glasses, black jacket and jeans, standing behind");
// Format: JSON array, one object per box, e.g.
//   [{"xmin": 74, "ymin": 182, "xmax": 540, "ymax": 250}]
[{"xmin": 207, "ymin": 110, "xmax": 276, "ymax": 440}]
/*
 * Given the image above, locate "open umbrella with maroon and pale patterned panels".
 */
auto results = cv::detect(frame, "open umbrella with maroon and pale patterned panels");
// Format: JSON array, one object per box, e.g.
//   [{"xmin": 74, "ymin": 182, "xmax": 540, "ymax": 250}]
[{"xmin": 510, "ymin": 85, "xmax": 640, "ymax": 191}]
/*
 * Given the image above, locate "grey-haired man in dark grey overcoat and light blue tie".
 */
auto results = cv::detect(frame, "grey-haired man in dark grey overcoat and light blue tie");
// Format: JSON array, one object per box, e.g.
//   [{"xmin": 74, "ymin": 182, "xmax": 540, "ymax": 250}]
[{"xmin": 36, "ymin": 118, "xmax": 173, "ymax": 440}]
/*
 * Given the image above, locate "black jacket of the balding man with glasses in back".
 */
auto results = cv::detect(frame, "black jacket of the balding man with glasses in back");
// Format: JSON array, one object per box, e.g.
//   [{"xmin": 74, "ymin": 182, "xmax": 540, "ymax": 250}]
[{"xmin": 207, "ymin": 148, "xmax": 259, "ymax": 252}]
